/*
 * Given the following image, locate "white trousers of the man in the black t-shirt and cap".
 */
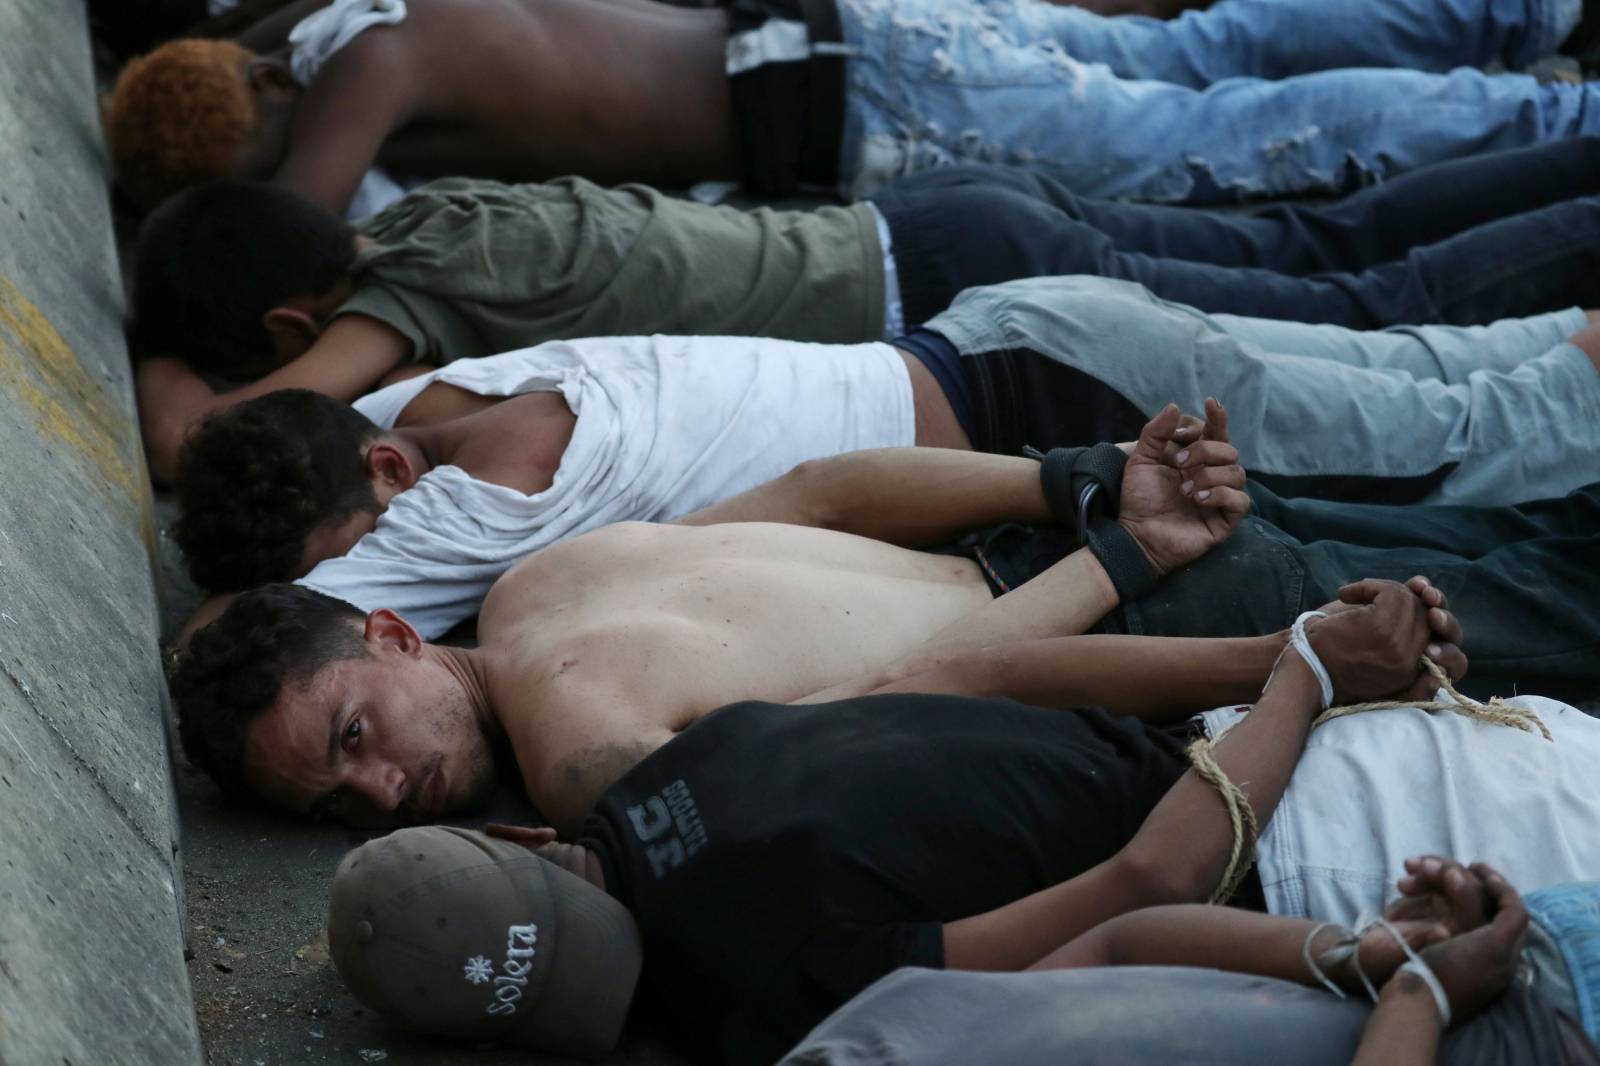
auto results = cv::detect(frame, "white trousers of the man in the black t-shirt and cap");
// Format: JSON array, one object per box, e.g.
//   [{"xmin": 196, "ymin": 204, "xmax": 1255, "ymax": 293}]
[{"xmin": 1241, "ymin": 696, "xmax": 1600, "ymax": 925}]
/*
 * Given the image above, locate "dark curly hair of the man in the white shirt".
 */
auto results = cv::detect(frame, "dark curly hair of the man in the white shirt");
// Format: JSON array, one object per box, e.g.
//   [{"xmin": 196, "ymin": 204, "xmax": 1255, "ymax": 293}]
[{"xmin": 173, "ymin": 389, "xmax": 382, "ymax": 592}]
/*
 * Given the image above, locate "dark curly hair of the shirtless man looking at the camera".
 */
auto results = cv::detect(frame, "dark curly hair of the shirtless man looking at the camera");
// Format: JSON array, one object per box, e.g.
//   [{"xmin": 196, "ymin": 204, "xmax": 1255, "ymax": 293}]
[{"xmin": 168, "ymin": 584, "xmax": 366, "ymax": 797}]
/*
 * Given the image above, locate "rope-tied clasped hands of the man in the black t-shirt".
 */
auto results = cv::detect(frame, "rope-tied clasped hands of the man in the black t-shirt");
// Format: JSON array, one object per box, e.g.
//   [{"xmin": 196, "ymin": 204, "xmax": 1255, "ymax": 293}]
[{"xmin": 1285, "ymin": 578, "xmax": 1467, "ymax": 704}]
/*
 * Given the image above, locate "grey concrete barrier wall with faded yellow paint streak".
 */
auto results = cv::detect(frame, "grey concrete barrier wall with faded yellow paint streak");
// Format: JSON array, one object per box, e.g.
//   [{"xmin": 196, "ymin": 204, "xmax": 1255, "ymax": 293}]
[{"xmin": 0, "ymin": 0, "xmax": 200, "ymax": 1066}]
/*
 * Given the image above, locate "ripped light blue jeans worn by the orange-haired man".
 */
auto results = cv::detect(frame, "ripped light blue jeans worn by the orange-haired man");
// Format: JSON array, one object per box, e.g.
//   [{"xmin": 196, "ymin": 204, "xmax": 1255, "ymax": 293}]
[{"xmin": 838, "ymin": 0, "xmax": 1600, "ymax": 202}]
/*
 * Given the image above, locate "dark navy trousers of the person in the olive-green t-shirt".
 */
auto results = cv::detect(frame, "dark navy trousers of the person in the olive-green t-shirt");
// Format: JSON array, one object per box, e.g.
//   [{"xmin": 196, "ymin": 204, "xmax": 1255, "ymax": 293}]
[{"xmin": 874, "ymin": 161, "xmax": 1600, "ymax": 330}]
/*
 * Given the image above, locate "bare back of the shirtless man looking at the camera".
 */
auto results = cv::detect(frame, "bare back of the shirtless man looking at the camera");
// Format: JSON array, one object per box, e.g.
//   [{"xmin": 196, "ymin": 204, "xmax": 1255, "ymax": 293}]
[{"xmin": 478, "ymin": 522, "xmax": 992, "ymax": 824}]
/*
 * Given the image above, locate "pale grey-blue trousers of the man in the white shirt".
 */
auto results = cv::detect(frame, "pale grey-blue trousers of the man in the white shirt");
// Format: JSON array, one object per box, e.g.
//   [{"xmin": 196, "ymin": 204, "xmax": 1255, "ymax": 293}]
[{"xmin": 928, "ymin": 277, "xmax": 1600, "ymax": 504}]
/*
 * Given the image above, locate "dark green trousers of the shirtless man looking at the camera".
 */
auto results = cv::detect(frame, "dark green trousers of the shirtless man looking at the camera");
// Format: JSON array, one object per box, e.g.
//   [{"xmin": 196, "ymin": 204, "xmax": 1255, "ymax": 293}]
[{"xmin": 1101, "ymin": 483, "xmax": 1600, "ymax": 699}]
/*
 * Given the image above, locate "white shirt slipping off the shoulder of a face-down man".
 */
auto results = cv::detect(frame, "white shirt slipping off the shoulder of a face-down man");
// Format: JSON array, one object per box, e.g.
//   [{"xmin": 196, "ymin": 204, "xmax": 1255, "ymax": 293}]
[{"xmin": 301, "ymin": 336, "xmax": 915, "ymax": 639}]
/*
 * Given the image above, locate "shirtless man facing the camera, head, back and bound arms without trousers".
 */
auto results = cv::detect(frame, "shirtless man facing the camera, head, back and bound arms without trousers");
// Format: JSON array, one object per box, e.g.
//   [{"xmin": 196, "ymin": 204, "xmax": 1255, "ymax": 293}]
[{"xmin": 173, "ymin": 408, "xmax": 1259, "ymax": 826}]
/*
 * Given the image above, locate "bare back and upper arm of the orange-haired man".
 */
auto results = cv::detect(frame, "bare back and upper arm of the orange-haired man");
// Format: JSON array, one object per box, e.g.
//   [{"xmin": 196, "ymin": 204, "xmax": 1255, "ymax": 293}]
[{"xmin": 275, "ymin": 0, "xmax": 738, "ymax": 208}]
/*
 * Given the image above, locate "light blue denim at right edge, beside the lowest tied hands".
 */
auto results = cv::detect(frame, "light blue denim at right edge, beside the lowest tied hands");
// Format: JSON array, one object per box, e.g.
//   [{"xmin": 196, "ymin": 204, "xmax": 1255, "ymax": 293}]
[{"xmin": 1523, "ymin": 880, "xmax": 1600, "ymax": 1044}]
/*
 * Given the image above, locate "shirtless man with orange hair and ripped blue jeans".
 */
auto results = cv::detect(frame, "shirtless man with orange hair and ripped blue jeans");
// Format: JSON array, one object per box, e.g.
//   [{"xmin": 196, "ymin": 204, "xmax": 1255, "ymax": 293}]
[{"xmin": 107, "ymin": 0, "xmax": 1595, "ymax": 210}]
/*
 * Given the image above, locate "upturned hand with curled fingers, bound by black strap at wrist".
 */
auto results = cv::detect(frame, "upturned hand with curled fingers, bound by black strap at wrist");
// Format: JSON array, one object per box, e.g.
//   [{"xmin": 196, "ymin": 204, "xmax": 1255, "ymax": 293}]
[{"xmin": 1117, "ymin": 399, "xmax": 1250, "ymax": 575}]
